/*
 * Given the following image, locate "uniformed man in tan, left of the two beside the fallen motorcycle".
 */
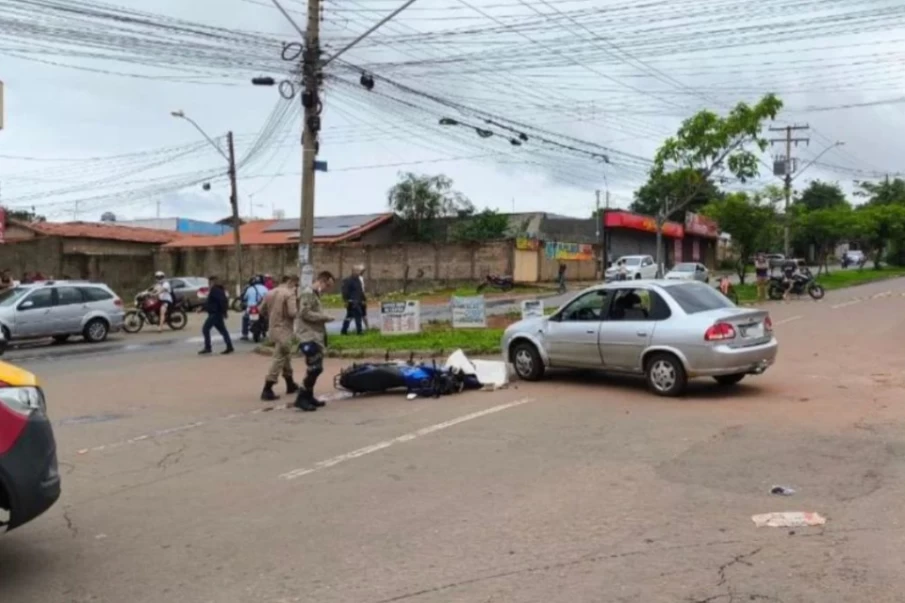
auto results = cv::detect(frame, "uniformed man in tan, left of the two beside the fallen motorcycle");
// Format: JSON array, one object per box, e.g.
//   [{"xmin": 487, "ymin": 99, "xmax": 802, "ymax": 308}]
[{"xmin": 261, "ymin": 276, "xmax": 299, "ymax": 402}]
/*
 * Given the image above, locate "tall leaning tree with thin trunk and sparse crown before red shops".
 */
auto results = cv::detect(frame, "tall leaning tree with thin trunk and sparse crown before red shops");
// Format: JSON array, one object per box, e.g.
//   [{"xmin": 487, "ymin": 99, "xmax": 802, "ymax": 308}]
[{"xmin": 649, "ymin": 94, "xmax": 782, "ymax": 273}]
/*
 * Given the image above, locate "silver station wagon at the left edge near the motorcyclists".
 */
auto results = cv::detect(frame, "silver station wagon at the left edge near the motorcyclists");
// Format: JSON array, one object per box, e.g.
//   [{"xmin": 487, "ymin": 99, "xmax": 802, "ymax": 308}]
[{"xmin": 0, "ymin": 281, "xmax": 125, "ymax": 343}]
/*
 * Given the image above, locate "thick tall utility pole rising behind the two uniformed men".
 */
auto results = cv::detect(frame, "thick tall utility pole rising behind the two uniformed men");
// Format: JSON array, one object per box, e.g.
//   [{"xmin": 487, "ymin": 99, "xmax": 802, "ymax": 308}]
[{"xmin": 299, "ymin": 0, "xmax": 321, "ymax": 287}]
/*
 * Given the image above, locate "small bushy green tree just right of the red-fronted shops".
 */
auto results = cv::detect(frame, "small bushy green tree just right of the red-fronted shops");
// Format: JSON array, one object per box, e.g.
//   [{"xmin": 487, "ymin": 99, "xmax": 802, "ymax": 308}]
[{"xmin": 703, "ymin": 193, "xmax": 776, "ymax": 285}]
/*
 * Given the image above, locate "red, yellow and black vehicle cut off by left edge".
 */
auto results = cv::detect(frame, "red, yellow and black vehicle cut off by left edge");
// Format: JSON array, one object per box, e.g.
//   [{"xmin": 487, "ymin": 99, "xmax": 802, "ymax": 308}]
[{"xmin": 0, "ymin": 341, "xmax": 60, "ymax": 531}]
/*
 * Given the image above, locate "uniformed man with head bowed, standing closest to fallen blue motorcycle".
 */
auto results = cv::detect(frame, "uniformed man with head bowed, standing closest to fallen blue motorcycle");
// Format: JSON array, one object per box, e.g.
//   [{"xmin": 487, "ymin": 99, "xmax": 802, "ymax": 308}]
[{"xmin": 295, "ymin": 270, "xmax": 336, "ymax": 411}]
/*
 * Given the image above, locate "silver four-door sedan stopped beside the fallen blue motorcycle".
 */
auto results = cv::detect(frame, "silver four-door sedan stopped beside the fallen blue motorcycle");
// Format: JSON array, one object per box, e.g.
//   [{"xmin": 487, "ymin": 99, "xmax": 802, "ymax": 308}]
[{"xmin": 502, "ymin": 280, "xmax": 779, "ymax": 396}]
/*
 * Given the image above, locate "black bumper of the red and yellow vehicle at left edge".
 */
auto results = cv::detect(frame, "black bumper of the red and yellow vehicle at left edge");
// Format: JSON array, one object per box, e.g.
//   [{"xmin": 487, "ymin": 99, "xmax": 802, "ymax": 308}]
[{"xmin": 0, "ymin": 417, "xmax": 61, "ymax": 530}]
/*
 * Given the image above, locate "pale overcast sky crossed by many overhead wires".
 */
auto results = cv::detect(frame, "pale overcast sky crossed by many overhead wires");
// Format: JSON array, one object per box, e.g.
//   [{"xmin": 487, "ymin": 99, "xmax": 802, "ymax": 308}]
[{"xmin": 0, "ymin": 0, "xmax": 905, "ymax": 220}]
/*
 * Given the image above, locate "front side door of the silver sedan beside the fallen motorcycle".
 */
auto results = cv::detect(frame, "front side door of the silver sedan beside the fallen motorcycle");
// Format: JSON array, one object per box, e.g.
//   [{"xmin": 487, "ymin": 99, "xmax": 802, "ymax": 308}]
[{"xmin": 544, "ymin": 289, "xmax": 609, "ymax": 368}]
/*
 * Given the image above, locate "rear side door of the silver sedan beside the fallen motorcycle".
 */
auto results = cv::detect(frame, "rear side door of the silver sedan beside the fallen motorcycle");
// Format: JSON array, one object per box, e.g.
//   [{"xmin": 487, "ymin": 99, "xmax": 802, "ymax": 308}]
[{"xmin": 600, "ymin": 287, "xmax": 669, "ymax": 372}]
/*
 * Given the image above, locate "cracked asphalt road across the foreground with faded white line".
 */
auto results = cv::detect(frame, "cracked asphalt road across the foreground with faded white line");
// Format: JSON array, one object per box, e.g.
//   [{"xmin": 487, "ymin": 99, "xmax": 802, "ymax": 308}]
[{"xmin": 0, "ymin": 280, "xmax": 905, "ymax": 603}]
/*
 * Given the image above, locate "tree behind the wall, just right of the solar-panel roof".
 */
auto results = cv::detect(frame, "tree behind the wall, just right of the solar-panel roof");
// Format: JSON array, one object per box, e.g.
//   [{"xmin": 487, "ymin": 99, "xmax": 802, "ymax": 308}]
[{"xmin": 387, "ymin": 172, "xmax": 474, "ymax": 241}]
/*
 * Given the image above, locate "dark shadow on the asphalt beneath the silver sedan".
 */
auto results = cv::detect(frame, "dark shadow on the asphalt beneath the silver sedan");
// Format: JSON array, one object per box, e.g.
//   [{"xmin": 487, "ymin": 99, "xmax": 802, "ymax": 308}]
[{"xmin": 544, "ymin": 370, "xmax": 767, "ymax": 401}]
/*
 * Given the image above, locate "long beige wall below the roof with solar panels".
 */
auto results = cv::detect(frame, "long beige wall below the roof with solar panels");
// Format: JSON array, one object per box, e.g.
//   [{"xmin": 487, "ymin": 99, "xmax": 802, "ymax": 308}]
[{"xmin": 155, "ymin": 241, "xmax": 512, "ymax": 292}]
